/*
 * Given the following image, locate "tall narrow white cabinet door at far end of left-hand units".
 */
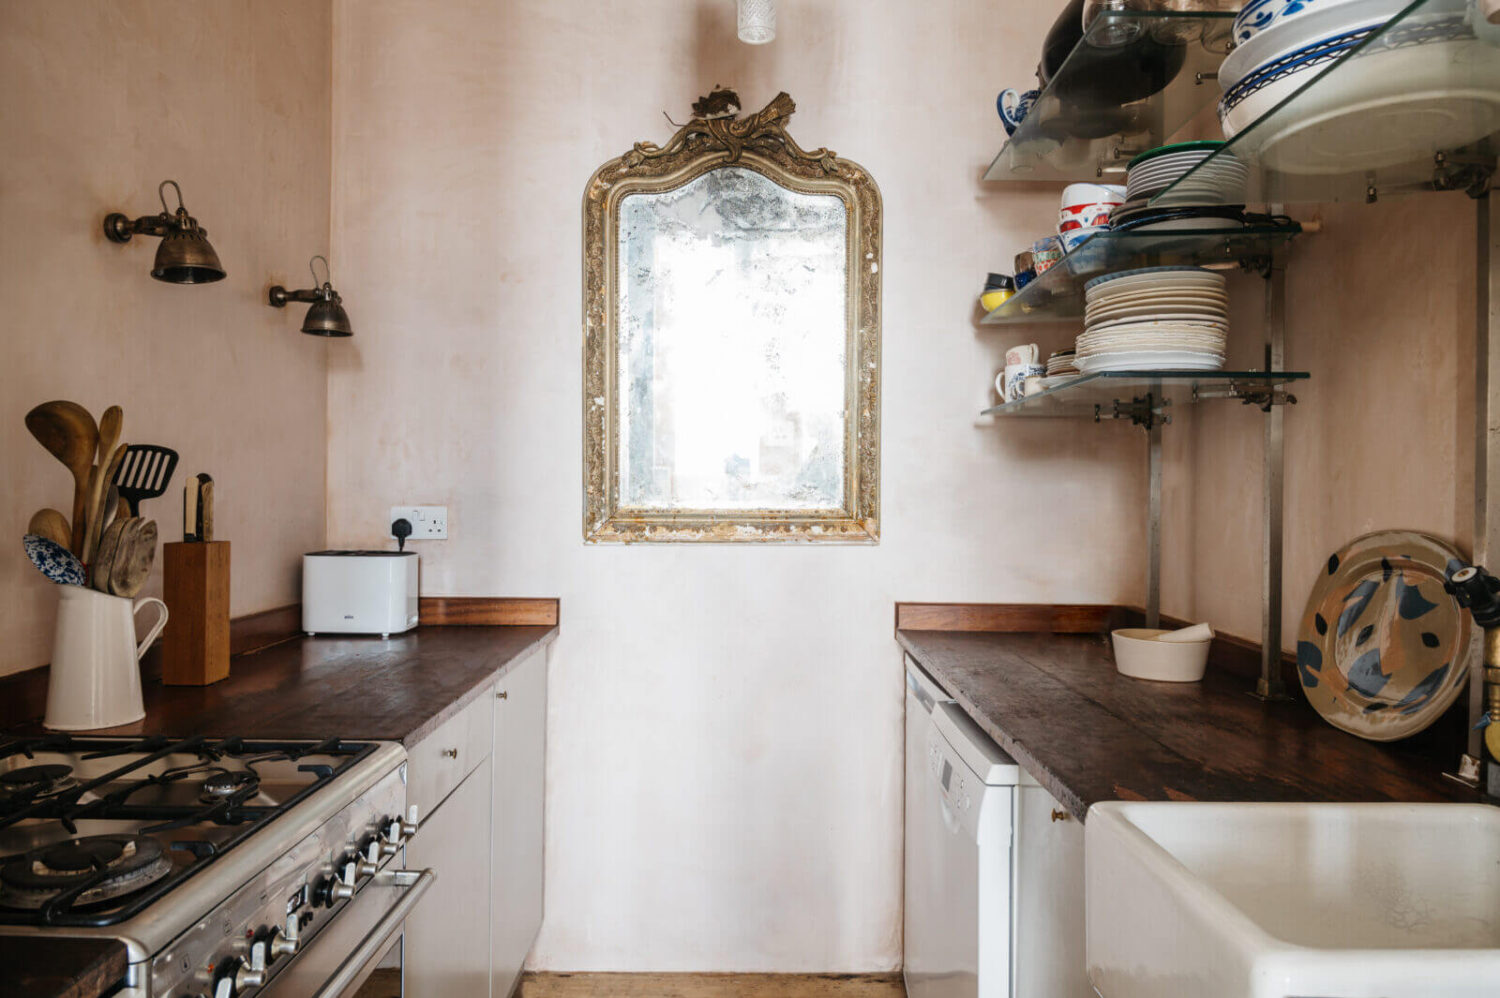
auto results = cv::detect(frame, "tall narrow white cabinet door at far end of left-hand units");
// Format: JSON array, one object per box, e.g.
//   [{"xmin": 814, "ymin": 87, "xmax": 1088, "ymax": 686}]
[{"xmin": 491, "ymin": 647, "xmax": 551, "ymax": 998}]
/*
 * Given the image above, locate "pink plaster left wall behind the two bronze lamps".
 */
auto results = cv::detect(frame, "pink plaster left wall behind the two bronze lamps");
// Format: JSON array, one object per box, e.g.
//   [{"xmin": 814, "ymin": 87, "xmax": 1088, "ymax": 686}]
[{"xmin": 0, "ymin": 0, "xmax": 334, "ymax": 672}]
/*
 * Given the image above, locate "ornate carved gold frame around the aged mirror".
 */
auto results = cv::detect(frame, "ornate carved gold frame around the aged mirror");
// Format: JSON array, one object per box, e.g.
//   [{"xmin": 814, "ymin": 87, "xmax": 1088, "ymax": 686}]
[{"xmin": 584, "ymin": 87, "xmax": 881, "ymax": 543}]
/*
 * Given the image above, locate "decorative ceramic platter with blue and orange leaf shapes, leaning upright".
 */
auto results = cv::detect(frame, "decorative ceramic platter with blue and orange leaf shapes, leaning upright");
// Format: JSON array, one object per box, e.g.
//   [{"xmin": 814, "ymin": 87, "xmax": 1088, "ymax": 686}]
[{"xmin": 1298, "ymin": 530, "xmax": 1473, "ymax": 741}]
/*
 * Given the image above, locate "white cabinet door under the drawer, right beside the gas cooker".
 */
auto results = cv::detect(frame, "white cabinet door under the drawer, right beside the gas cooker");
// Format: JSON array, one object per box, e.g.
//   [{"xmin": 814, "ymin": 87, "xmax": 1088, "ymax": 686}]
[{"xmin": 401, "ymin": 758, "xmax": 494, "ymax": 998}]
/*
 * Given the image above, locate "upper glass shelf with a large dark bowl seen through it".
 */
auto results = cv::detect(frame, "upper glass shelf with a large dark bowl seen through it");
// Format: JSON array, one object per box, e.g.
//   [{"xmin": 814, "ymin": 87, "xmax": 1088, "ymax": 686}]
[{"xmin": 984, "ymin": 11, "xmax": 1235, "ymax": 183}]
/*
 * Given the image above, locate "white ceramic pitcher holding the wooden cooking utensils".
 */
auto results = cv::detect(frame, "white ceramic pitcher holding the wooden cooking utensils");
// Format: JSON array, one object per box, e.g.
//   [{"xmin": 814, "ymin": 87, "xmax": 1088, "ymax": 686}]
[{"xmin": 44, "ymin": 585, "xmax": 167, "ymax": 731}]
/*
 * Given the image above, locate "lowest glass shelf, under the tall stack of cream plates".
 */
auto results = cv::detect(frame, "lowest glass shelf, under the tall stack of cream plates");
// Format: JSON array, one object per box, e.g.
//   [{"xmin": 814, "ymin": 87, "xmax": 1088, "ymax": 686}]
[{"xmin": 981, "ymin": 371, "xmax": 1310, "ymax": 419}]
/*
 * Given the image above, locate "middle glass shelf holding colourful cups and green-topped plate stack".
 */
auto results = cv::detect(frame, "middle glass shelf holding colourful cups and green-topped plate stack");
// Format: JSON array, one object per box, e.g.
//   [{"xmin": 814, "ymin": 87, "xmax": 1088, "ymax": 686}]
[{"xmin": 981, "ymin": 222, "xmax": 1302, "ymax": 326}]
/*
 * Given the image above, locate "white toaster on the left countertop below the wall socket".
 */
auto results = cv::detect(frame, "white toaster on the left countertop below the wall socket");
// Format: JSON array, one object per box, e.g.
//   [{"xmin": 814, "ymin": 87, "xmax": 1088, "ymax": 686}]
[{"xmin": 302, "ymin": 551, "xmax": 417, "ymax": 638}]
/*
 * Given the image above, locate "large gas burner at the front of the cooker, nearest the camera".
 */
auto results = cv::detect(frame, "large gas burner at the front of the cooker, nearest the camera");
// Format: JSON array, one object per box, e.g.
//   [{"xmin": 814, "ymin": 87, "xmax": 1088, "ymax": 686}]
[{"xmin": 0, "ymin": 834, "xmax": 173, "ymax": 908}]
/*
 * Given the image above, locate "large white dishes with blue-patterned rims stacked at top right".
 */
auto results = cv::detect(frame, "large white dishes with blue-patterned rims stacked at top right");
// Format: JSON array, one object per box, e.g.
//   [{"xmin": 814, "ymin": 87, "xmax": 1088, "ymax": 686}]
[{"xmin": 1218, "ymin": 0, "xmax": 1500, "ymax": 174}]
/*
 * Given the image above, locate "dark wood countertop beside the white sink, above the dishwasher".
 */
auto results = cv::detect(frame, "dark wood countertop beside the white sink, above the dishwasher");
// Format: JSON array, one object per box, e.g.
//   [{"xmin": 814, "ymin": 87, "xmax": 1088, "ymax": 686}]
[{"xmin": 897, "ymin": 630, "xmax": 1479, "ymax": 819}]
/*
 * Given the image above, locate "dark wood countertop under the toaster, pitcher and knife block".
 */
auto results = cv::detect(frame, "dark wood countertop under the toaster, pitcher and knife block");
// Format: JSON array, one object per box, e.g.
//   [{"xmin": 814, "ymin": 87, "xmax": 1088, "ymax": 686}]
[{"xmin": 0, "ymin": 624, "xmax": 558, "ymax": 744}]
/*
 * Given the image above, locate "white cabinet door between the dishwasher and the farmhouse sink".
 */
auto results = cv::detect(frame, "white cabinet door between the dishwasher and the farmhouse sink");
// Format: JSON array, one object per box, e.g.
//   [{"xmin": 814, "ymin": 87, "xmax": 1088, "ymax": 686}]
[{"xmin": 1014, "ymin": 780, "xmax": 1094, "ymax": 998}]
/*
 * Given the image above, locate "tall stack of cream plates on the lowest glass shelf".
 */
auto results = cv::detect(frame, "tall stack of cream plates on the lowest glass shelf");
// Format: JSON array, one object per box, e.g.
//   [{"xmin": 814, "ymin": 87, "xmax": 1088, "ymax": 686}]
[{"xmin": 1077, "ymin": 267, "xmax": 1229, "ymax": 374}]
